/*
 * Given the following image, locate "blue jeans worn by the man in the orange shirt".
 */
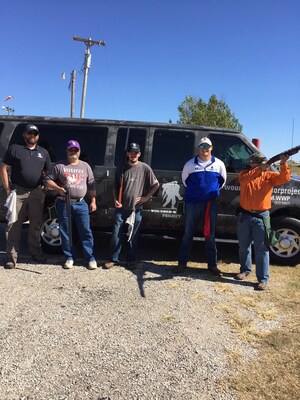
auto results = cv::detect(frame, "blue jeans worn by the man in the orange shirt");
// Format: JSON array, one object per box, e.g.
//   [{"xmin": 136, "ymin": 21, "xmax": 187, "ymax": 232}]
[{"xmin": 237, "ymin": 211, "xmax": 269, "ymax": 282}]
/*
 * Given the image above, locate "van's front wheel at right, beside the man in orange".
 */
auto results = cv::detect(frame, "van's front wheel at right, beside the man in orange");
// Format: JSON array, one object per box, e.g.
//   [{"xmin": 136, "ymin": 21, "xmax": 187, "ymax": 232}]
[{"xmin": 270, "ymin": 217, "xmax": 300, "ymax": 266}]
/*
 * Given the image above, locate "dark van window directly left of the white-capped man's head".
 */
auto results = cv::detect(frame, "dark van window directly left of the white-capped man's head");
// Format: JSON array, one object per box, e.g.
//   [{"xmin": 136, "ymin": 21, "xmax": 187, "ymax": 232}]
[{"xmin": 151, "ymin": 129, "xmax": 195, "ymax": 171}]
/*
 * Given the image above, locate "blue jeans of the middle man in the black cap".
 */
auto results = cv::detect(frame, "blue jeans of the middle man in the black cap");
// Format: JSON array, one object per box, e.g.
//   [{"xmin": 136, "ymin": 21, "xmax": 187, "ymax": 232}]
[{"xmin": 111, "ymin": 208, "xmax": 142, "ymax": 263}]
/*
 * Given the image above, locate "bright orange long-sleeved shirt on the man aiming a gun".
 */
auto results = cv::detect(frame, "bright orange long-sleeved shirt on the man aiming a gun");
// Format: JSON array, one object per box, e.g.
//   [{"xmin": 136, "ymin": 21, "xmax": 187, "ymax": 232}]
[{"xmin": 239, "ymin": 163, "xmax": 291, "ymax": 211}]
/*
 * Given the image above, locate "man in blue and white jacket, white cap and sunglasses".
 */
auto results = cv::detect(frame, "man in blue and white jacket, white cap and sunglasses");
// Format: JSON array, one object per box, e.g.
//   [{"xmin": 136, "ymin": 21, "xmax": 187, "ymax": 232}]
[{"xmin": 174, "ymin": 137, "xmax": 226, "ymax": 276}]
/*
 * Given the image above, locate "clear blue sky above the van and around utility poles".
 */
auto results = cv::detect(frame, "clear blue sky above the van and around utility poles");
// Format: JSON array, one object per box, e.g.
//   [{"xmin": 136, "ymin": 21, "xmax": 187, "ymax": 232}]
[{"xmin": 0, "ymin": 0, "xmax": 300, "ymax": 159}]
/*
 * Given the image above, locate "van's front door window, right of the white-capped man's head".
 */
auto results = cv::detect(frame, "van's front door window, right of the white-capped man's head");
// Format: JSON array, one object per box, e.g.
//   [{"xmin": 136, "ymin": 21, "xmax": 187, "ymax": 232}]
[{"xmin": 209, "ymin": 134, "xmax": 253, "ymax": 172}]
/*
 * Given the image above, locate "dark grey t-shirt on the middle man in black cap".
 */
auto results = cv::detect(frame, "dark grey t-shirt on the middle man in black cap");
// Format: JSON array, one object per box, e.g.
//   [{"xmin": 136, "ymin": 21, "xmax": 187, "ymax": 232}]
[{"xmin": 115, "ymin": 161, "xmax": 158, "ymax": 210}]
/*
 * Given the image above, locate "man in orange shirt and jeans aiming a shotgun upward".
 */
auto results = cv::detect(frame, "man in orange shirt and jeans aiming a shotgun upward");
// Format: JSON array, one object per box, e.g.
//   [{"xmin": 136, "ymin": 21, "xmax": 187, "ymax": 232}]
[{"xmin": 235, "ymin": 153, "xmax": 290, "ymax": 290}]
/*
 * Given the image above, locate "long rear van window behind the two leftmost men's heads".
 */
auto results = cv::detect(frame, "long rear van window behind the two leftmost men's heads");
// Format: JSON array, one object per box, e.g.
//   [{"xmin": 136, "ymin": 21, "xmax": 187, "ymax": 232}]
[{"xmin": 9, "ymin": 124, "xmax": 108, "ymax": 167}]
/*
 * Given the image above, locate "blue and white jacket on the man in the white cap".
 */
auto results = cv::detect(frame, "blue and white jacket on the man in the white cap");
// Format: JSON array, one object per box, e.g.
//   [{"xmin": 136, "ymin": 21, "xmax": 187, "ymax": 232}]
[{"xmin": 181, "ymin": 156, "xmax": 227, "ymax": 203}]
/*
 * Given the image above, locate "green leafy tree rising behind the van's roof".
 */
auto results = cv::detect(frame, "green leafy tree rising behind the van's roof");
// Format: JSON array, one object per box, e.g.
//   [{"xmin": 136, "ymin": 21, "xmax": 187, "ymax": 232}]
[{"xmin": 178, "ymin": 94, "xmax": 243, "ymax": 132}]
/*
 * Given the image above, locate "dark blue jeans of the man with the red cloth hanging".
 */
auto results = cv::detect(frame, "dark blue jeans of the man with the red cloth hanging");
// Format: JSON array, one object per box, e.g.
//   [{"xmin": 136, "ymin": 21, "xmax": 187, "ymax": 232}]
[{"xmin": 179, "ymin": 199, "xmax": 218, "ymax": 269}]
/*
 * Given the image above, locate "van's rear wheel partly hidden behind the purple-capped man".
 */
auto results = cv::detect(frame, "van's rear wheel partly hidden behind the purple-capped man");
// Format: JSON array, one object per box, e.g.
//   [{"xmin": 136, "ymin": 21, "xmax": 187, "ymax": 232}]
[{"xmin": 40, "ymin": 214, "xmax": 62, "ymax": 254}]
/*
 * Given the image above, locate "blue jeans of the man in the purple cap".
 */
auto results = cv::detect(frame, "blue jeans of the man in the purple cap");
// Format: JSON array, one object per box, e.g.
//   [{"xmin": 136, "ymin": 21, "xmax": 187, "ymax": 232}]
[{"xmin": 55, "ymin": 199, "xmax": 95, "ymax": 262}]
